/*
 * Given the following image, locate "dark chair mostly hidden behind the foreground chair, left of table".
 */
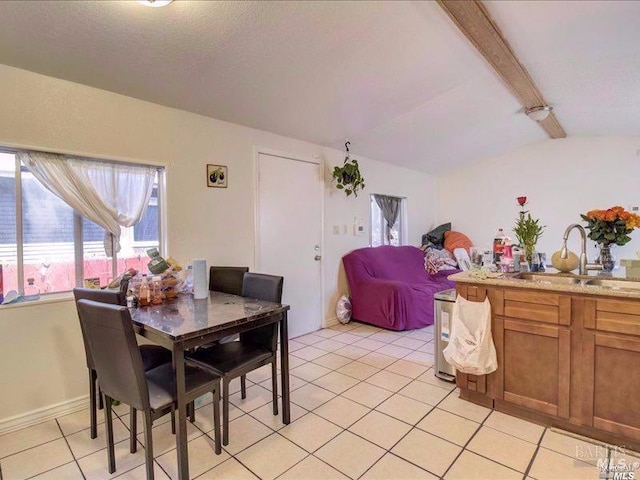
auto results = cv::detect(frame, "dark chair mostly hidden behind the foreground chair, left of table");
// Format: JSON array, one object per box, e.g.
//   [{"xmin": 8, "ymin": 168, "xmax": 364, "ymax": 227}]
[{"xmin": 73, "ymin": 288, "xmax": 171, "ymax": 438}]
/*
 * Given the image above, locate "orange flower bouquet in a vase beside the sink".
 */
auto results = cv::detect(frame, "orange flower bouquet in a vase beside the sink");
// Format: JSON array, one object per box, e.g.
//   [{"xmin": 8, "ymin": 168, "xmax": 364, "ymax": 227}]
[{"xmin": 580, "ymin": 206, "xmax": 640, "ymax": 247}]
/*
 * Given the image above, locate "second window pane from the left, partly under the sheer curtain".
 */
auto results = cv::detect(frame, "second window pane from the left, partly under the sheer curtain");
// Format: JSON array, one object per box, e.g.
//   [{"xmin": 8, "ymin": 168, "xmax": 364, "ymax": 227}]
[{"xmin": 22, "ymin": 167, "xmax": 76, "ymax": 295}]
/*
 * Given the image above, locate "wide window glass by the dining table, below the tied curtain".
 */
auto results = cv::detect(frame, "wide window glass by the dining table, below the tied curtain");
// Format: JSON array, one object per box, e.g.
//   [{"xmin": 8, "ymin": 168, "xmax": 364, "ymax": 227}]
[{"xmin": 0, "ymin": 150, "xmax": 164, "ymax": 295}]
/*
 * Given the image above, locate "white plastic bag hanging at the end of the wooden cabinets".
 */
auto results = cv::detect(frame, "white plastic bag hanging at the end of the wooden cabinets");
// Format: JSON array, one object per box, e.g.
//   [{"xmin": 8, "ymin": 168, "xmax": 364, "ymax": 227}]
[{"xmin": 442, "ymin": 295, "xmax": 498, "ymax": 375}]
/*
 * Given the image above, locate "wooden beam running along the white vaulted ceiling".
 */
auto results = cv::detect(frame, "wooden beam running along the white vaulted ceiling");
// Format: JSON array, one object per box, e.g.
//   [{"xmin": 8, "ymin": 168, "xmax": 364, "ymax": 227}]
[{"xmin": 437, "ymin": 0, "xmax": 567, "ymax": 138}]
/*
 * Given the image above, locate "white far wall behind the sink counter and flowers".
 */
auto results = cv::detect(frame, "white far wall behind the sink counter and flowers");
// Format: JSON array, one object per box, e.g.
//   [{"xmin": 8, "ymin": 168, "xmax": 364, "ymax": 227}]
[{"xmin": 437, "ymin": 137, "xmax": 640, "ymax": 262}]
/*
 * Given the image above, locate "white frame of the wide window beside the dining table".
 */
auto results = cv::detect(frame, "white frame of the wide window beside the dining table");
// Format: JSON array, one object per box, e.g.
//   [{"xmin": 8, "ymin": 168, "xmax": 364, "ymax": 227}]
[{"xmin": 0, "ymin": 146, "xmax": 167, "ymax": 295}]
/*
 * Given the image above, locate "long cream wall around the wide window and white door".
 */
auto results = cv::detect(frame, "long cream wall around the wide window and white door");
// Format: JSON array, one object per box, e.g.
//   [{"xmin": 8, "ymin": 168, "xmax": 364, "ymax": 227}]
[{"xmin": 0, "ymin": 66, "xmax": 436, "ymax": 429}]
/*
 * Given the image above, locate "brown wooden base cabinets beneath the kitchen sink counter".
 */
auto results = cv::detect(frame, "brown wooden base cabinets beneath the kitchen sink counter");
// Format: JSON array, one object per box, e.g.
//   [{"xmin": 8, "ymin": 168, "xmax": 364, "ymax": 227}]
[{"xmin": 456, "ymin": 284, "xmax": 640, "ymax": 448}]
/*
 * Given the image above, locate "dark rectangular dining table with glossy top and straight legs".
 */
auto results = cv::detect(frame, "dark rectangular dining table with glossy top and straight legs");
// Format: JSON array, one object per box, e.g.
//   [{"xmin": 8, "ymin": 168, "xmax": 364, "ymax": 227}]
[{"xmin": 130, "ymin": 291, "xmax": 291, "ymax": 480}]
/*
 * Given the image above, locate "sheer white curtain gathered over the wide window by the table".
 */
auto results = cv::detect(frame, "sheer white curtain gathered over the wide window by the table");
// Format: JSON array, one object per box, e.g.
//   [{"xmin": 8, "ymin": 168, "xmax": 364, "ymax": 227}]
[{"xmin": 18, "ymin": 151, "xmax": 156, "ymax": 256}]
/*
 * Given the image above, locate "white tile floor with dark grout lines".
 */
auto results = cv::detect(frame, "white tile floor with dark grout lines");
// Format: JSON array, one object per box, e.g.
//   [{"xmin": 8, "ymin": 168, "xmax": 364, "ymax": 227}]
[{"xmin": 0, "ymin": 323, "xmax": 624, "ymax": 480}]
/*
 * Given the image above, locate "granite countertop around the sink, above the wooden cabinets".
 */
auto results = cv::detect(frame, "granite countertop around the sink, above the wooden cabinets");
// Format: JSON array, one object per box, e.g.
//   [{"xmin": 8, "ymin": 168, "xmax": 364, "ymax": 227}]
[{"xmin": 447, "ymin": 270, "xmax": 640, "ymax": 299}]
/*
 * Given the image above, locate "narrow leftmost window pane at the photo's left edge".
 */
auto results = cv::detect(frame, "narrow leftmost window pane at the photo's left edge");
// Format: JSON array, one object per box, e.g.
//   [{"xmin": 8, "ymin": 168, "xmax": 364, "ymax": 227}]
[{"xmin": 0, "ymin": 152, "xmax": 18, "ymax": 293}]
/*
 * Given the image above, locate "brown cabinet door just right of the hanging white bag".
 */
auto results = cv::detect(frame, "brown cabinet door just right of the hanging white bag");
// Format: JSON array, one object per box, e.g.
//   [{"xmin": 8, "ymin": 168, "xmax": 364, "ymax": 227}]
[{"xmin": 494, "ymin": 318, "xmax": 571, "ymax": 418}]
